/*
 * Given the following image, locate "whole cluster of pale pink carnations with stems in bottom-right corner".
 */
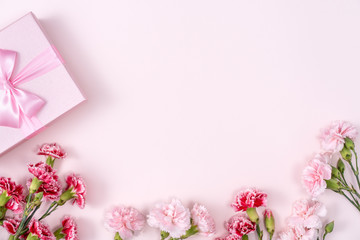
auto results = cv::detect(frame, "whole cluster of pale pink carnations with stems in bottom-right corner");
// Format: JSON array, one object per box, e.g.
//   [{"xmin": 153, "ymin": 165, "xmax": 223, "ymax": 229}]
[{"xmin": 279, "ymin": 121, "xmax": 360, "ymax": 240}]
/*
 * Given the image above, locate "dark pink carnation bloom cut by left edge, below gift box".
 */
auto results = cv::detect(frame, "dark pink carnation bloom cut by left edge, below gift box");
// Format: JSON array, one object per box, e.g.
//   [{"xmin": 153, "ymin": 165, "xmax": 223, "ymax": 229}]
[{"xmin": 0, "ymin": 177, "xmax": 24, "ymax": 213}]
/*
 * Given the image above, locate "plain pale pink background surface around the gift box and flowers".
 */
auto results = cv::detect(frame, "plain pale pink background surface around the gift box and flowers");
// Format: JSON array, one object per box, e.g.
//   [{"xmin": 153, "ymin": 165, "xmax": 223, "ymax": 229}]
[{"xmin": 0, "ymin": 0, "xmax": 360, "ymax": 240}]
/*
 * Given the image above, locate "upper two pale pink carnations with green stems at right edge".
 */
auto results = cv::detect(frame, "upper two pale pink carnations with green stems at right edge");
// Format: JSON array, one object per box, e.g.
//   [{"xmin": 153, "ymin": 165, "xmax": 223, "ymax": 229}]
[{"xmin": 302, "ymin": 121, "xmax": 360, "ymax": 199}]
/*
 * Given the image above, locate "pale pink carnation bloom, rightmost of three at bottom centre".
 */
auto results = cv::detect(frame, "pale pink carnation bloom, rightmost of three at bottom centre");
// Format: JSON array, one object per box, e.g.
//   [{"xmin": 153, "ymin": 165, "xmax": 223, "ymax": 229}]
[{"xmin": 191, "ymin": 203, "xmax": 215, "ymax": 237}]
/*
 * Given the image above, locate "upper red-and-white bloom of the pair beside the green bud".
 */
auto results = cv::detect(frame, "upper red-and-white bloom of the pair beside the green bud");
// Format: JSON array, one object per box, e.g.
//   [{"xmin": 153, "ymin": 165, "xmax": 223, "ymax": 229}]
[{"xmin": 231, "ymin": 188, "xmax": 267, "ymax": 212}]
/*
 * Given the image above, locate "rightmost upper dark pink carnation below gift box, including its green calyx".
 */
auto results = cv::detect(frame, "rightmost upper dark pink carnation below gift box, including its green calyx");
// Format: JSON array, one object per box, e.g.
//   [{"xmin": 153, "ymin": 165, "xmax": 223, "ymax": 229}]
[{"xmin": 59, "ymin": 174, "xmax": 86, "ymax": 208}]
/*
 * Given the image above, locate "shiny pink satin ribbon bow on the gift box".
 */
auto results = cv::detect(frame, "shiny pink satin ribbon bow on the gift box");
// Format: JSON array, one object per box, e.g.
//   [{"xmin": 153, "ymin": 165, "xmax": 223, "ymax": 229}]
[{"xmin": 0, "ymin": 48, "xmax": 61, "ymax": 133}]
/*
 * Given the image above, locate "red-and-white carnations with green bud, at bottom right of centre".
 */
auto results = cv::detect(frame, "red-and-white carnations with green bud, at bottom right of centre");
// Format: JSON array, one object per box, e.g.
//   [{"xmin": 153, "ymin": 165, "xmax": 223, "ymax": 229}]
[{"xmin": 217, "ymin": 189, "xmax": 275, "ymax": 240}]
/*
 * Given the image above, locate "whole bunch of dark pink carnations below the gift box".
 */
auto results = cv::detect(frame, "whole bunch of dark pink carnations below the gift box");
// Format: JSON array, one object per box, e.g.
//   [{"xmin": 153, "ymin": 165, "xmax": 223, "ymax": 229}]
[{"xmin": 0, "ymin": 143, "xmax": 86, "ymax": 240}]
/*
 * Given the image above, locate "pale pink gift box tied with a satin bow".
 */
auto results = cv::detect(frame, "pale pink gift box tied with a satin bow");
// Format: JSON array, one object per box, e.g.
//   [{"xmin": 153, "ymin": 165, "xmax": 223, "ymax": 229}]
[{"xmin": 0, "ymin": 13, "xmax": 85, "ymax": 154}]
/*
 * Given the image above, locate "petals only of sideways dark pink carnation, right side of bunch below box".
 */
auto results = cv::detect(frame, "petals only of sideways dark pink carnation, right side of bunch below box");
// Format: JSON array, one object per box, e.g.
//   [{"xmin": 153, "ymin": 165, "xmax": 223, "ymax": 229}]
[{"xmin": 66, "ymin": 174, "xmax": 86, "ymax": 208}]
